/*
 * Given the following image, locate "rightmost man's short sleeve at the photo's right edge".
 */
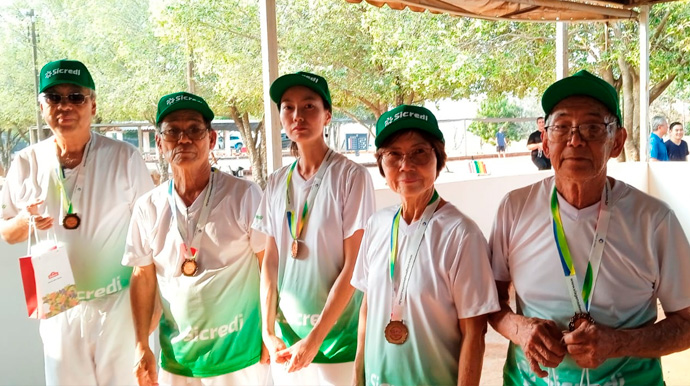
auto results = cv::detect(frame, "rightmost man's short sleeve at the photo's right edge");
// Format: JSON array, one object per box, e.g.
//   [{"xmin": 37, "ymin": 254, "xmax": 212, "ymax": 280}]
[{"xmin": 654, "ymin": 210, "xmax": 690, "ymax": 312}]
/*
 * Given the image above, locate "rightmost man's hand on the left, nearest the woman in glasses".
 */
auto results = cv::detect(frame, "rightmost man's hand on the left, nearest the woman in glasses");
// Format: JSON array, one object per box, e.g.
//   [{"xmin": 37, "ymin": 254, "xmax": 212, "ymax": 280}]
[{"xmin": 517, "ymin": 318, "xmax": 566, "ymax": 378}]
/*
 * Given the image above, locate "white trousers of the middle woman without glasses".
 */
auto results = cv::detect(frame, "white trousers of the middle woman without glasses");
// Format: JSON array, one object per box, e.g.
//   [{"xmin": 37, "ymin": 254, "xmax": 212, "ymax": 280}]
[{"xmin": 271, "ymin": 362, "xmax": 355, "ymax": 386}]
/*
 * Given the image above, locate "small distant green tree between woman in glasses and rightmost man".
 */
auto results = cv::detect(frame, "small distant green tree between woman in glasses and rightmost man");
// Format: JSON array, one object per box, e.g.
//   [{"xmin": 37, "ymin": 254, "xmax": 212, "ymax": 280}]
[{"xmin": 468, "ymin": 96, "xmax": 527, "ymax": 145}]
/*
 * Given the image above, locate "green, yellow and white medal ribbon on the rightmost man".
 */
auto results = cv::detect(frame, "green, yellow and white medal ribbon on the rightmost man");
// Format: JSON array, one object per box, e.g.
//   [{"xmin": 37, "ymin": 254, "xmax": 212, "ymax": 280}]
[{"xmin": 551, "ymin": 179, "xmax": 611, "ymax": 313}]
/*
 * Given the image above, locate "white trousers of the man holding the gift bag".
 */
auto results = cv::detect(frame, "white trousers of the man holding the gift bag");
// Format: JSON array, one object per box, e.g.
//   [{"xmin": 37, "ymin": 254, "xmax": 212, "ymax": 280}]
[{"xmin": 39, "ymin": 289, "xmax": 137, "ymax": 386}]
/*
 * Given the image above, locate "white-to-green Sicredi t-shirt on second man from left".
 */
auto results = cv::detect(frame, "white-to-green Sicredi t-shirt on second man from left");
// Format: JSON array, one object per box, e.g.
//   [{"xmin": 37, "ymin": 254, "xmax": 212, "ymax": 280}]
[{"xmin": 122, "ymin": 171, "xmax": 266, "ymax": 377}]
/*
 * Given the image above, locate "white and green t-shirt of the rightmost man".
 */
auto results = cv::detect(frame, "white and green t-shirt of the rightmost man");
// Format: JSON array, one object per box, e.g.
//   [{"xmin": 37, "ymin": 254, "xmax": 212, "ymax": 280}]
[{"xmin": 489, "ymin": 177, "xmax": 690, "ymax": 383}]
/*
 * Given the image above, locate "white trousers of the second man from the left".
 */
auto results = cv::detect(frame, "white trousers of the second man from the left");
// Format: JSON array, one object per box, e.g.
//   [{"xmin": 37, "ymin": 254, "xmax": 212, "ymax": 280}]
[{"xmin": 158, "ymin": 363, "xmax": 272, "ymax": 386}]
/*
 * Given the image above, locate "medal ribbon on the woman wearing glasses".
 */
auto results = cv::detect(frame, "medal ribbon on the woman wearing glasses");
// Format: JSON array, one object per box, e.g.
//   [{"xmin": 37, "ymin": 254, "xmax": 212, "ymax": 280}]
[{"xmin": 390, "ymin": 189, "xmax": 441, "ymax": 321}]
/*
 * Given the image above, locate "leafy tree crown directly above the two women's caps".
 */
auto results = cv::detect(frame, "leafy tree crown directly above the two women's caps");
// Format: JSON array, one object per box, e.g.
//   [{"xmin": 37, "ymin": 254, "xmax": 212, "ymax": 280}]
[{"xmin": 278, "ymin": 0, "xmax": 469, "ymax": 130}]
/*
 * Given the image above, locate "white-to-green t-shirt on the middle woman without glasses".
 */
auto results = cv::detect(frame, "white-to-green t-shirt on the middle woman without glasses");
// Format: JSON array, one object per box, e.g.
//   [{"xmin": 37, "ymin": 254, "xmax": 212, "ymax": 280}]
[{"xmin": 253, "ymin": 154, "xmax": 374, "ymax": 363}]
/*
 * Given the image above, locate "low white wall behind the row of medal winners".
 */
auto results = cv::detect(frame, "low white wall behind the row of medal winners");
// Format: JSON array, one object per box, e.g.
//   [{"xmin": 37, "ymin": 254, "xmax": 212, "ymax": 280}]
[{"xmin": 0, "ymin": 162, "xmax": 690, "ymax": 385}]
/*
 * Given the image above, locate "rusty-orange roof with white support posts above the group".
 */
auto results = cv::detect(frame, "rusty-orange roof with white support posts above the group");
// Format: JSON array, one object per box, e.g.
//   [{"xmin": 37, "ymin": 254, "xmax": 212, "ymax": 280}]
[{"xmin": 259, "ymin": 0, "xmax": 676, "ymax": 173}]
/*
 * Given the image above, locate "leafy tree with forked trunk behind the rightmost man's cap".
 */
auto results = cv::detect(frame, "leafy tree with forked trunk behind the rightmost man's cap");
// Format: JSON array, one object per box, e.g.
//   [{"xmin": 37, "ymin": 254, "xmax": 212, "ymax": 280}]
[{"xmin": 446, "ymin": 2, "xmax": 690, "ymax": 160}]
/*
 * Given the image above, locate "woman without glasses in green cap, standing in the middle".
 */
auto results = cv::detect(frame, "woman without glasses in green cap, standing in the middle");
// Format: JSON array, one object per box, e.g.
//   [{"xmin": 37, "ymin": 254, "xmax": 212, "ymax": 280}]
[{"xmin": 253, "ymin": 72, "xmax": 374, "ymax": 385}]
